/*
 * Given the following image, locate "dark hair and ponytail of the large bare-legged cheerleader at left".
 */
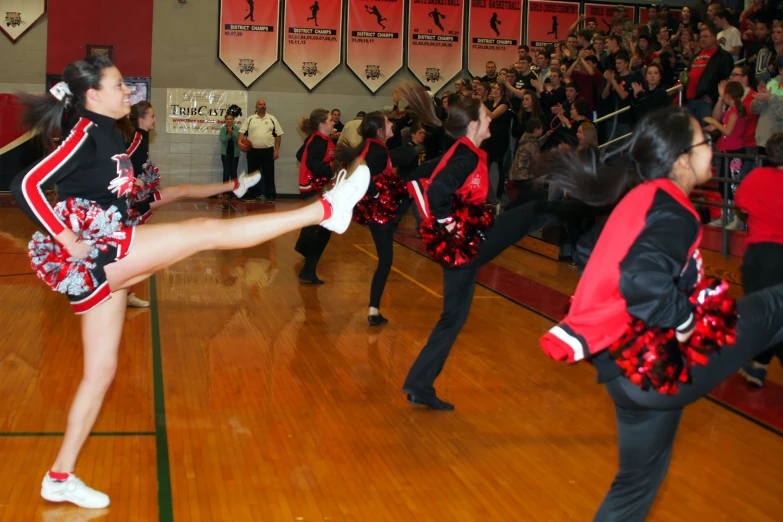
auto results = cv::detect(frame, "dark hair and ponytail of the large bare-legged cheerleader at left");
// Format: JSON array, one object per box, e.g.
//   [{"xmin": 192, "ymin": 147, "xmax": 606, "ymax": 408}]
[{"xmin": 18, "ymin": 56, "xmax": 114, "ymax": 149}]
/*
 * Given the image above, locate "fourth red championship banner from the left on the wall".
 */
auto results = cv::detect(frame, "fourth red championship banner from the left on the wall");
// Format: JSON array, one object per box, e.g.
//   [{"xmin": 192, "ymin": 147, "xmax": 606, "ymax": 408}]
[{"xmin": 408, "ymin": 0, "xmax": 465, "ymax": 93}]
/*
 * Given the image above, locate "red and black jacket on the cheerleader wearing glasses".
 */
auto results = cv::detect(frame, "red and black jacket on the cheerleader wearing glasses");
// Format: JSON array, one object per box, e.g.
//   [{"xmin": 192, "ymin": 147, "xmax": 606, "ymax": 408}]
[{"xmin": 541, "ymin": 179, "xmax": 704, "ymax": 374}]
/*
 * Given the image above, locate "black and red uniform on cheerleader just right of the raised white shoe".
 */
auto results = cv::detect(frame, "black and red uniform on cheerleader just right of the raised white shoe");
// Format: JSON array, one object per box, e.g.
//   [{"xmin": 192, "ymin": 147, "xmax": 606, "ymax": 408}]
[{"xmin": 362, "ymin": 138, "xmax": 418, "ymax": 318}]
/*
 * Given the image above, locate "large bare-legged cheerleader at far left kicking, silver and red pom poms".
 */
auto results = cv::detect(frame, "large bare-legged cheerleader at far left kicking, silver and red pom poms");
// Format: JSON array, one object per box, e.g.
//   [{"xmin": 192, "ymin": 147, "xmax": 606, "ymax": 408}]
[{"xmin": 11, "ymin": 56, "xmax": 370, "ymax": 508}]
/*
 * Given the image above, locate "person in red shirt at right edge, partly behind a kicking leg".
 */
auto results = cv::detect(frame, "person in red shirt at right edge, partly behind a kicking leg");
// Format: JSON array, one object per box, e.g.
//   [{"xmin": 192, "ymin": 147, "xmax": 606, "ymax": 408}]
[{"xmin": 734, "ymin": 132, "xmax": 783, "ymax": 386}]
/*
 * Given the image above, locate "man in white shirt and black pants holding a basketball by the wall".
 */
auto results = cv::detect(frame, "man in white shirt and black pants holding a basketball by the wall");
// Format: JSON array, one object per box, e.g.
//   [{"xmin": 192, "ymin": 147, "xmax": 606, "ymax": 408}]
[{"xmin": 239, "ymin": 100, "xmax": 283, "ymax": 203}]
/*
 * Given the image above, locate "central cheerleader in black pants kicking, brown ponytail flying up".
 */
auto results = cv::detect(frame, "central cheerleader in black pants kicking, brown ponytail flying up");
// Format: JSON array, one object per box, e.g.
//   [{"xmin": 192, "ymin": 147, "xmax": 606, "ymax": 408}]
[{"xmin": 402, "ymin": 87, "xmax": 555, "ymax": 410}]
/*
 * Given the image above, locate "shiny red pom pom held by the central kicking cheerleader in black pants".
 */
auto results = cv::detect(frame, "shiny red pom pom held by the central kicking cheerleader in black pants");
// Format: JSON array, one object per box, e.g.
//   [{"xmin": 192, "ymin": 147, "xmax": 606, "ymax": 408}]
[{"xmin": 419, "ymin": 193, "xmax": 494, "ymax": 268}]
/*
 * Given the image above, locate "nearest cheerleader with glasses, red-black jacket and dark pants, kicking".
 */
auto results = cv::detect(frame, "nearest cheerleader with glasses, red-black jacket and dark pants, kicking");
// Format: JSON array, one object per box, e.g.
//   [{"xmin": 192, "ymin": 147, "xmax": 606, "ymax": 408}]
[{"xmin": 539, "ymin": 107, "xmax": 783, "ymax": 522}]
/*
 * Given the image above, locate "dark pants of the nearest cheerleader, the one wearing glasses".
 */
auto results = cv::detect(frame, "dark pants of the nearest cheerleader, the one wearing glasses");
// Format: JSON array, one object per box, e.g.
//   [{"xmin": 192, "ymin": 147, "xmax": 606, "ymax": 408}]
[{"xmin": 594, "ymin": 285, "xmax": 783, "ymax": 522}]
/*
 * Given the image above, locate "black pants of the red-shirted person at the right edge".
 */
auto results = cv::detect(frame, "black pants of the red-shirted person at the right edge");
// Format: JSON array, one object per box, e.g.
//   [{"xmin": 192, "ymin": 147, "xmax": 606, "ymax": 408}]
[{"xmin": 742, "ymin": 243, "xmax": 783, "ymax": 364}]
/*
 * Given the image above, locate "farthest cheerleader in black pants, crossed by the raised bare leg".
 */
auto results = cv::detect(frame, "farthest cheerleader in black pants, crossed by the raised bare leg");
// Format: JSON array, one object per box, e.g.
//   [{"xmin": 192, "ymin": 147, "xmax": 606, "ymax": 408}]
[{"xmin": 295, "ymin": 109, "xmax": 335, "ymax": 285}]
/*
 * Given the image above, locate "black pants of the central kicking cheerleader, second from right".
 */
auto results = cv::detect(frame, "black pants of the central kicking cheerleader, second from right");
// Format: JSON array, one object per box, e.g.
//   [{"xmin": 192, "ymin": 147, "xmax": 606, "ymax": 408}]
[{"xmin": 403, "ymin": 202, "xmax": 556, "ymax": 397}]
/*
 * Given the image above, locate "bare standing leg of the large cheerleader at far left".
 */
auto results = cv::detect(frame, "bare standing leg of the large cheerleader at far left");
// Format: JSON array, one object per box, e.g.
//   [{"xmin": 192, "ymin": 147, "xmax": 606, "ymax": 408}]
[{"xmin": 52, "ymin": 290, "xmax": 126, "ymax": 473}]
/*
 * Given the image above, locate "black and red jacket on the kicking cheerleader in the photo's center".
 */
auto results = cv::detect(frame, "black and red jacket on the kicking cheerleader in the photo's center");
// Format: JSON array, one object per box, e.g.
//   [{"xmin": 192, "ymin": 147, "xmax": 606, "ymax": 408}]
[{"xmin": 413, "ymin": 136, "xmax": 489, "ymax": 219}]
